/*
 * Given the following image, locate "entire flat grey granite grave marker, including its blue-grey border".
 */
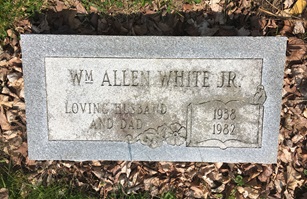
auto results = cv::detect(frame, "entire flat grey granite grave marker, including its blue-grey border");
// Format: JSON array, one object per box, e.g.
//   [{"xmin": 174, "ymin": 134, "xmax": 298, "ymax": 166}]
[{"xmin": 21, "ymin": 35, "xmax": 286, "ymax": 163}]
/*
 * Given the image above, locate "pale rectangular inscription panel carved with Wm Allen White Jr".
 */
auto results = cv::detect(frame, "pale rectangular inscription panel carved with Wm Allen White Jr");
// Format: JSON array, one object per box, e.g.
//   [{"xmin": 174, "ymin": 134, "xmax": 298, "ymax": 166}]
[{"xmin": 45, "ymin": 57, "xmax": 266, "ymax": 149}]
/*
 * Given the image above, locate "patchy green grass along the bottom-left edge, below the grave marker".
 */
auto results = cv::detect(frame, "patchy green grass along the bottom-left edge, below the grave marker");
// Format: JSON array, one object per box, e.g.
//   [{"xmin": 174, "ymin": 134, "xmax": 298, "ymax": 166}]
[{"xmin": 0, "ymin": 161, "xmax": 176, "ymax": 199}]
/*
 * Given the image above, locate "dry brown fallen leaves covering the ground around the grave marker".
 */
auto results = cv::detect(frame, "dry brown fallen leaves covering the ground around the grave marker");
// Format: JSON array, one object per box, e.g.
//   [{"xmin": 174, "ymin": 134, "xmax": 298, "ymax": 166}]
[{"xmin": 0, "ymin": 1, "xmax": 307, "ymax": 198}]
